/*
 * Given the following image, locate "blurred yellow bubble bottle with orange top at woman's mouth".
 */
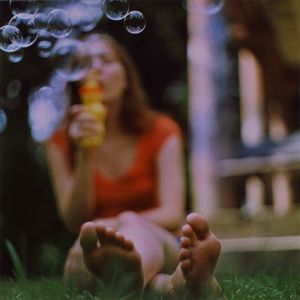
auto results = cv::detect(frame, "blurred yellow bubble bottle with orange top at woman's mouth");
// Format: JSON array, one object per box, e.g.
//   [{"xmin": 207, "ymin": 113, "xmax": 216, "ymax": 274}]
[{"xmin": 79, "ymin": 77, "xmax": 106, "ymax": 147}]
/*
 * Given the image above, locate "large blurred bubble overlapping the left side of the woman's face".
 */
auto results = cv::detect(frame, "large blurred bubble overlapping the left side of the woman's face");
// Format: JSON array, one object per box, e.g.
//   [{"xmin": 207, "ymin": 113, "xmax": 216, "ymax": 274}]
[{"xmin": 51, "ymin": 39, "xmax": 91, "ymax": 81}]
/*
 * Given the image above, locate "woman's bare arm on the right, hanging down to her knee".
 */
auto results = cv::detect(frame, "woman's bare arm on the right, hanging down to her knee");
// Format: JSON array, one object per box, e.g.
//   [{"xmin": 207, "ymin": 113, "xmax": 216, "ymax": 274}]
[{"xmin": 140, "ymin": 136, "xmax": 185, "ymax": 230}]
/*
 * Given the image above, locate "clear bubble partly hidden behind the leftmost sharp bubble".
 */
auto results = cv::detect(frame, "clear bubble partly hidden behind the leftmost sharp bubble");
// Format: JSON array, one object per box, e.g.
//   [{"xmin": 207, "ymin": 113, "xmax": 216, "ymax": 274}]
[{"xmin": 8, "ymin": 13, "xmax": 38, "ymax": 48}]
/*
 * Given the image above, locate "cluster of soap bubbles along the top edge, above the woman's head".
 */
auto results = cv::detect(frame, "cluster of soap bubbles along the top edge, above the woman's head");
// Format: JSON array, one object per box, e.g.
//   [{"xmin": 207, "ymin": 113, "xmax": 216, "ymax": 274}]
[{"xmin": 0, "ymin": 0, "xmax": 146, "ymax": 62}]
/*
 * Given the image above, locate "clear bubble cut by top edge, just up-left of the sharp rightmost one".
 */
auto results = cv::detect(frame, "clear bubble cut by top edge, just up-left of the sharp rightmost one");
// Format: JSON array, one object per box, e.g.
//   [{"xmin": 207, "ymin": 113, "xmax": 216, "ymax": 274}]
[{"xmin": 103, "ymin": 0, "xmax": 129, "ymax": 21}]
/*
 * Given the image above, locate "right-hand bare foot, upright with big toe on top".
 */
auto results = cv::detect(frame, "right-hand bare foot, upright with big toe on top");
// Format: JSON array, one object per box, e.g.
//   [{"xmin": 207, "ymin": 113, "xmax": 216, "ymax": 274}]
[{"xmin": 165, "ymin": 213, "xmax": 221, "ymax": 300}]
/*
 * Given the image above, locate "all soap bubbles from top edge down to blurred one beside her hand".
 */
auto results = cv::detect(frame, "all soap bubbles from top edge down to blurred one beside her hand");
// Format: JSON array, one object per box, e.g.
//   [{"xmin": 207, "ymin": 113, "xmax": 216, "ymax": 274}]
[{"xmin": 0, "ymin": 0, "xmax": 146, "ymax": 141}]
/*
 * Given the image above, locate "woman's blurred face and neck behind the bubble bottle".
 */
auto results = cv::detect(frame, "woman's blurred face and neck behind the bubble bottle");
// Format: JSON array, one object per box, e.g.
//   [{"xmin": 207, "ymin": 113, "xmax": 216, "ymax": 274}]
[{"xmin": 82, "ymin": 40, "xmax": 127, "ymax": 105}]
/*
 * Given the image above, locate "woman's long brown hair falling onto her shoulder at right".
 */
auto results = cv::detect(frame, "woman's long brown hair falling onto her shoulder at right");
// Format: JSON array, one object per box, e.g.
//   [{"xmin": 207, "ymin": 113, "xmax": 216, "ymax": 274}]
[{"xmin": 70, "ymin": 33, "xmax": 156, "ymax": 134}]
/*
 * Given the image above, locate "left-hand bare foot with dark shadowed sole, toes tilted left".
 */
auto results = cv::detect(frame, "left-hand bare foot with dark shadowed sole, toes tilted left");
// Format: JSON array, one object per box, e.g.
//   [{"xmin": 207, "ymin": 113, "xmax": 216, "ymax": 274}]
[{"xmin": 79, "ymin": 222, "xmax": 143, "ymax": 299}]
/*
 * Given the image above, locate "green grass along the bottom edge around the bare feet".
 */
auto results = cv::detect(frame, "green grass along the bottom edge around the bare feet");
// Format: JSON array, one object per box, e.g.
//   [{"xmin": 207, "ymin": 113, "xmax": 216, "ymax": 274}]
[{"xmin": 0, "ymin": 272, "xmax": 300, "ymax": 300}]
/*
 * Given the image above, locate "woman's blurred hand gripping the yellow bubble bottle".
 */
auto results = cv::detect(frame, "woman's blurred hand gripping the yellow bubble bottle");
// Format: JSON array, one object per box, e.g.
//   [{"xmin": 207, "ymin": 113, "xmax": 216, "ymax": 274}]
[{"xmin": 68, "ymin": 104, "xmax": 104, "ymax": 148}]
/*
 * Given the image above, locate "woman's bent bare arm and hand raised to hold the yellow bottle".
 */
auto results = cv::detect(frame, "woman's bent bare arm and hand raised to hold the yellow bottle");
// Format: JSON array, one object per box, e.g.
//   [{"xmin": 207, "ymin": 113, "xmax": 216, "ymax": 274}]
[{"xmin": 45, "ymin": 105, "xmax": 101, "ymax": 233}]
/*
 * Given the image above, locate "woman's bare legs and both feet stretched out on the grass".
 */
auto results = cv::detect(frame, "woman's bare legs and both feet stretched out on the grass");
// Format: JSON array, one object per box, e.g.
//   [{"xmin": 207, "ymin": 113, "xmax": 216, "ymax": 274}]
[{"xmin": 69, "ymin": 213, "xmax": 220, "ymax": 299}]
